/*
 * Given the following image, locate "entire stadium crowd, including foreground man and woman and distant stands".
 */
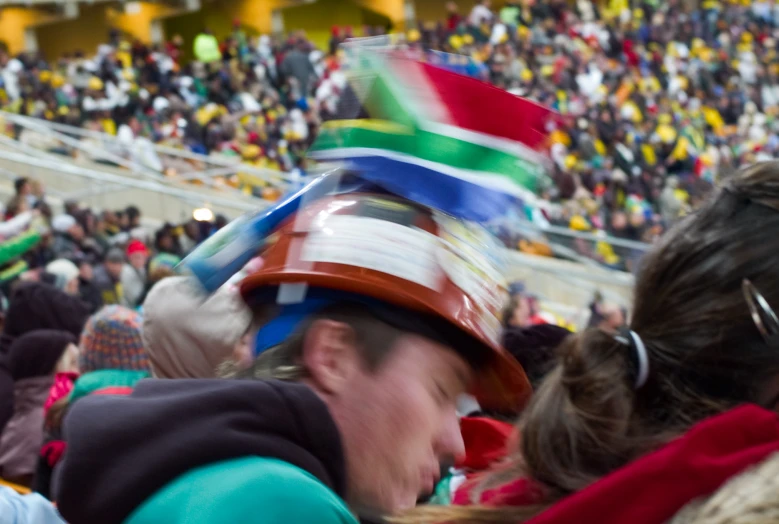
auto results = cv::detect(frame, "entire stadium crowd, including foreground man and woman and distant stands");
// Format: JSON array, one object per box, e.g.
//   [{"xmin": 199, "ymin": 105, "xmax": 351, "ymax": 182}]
[{"xmin": 0, "ymin": 0, "xmax": 779, "ymax": 524}]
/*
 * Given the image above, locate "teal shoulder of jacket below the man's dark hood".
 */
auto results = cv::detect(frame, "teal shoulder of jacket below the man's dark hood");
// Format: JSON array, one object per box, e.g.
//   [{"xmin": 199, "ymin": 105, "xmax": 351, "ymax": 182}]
[{"xmin": 125, "ymin": 457, "xmax": 358, "ymax": 524}]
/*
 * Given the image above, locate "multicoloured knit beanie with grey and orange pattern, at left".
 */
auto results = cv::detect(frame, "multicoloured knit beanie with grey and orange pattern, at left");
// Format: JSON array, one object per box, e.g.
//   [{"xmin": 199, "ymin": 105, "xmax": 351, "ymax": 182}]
[{"xmin": 79, "ymin": 306, "xmax": 150, "ymax": 373}]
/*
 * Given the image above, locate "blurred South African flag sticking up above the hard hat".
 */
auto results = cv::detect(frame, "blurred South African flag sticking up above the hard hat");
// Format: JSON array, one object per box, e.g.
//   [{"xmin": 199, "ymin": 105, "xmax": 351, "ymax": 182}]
[{"xmin": 309, "ymin": 50, "xmax": 553, "ymax": 221}]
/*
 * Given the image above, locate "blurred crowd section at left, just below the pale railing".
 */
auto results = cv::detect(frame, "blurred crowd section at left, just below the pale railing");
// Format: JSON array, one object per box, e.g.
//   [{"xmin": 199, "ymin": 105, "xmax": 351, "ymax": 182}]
[{"xmin": 0, "ymin": 178, "xmax": 227, "ymax": 312}]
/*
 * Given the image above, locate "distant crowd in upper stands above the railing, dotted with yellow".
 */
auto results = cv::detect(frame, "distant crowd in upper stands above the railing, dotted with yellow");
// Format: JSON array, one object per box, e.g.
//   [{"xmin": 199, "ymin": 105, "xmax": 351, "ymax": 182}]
[{"xmin": 0, "ymin": 0, "xmax": 779, "ymax": 254}]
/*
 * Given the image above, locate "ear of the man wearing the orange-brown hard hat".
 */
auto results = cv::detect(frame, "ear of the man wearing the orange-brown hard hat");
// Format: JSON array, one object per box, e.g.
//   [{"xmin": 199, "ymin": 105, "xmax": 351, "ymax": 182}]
[{"xmin": 303, "ymin": 319, "xmax": 360, "ymax": 395}]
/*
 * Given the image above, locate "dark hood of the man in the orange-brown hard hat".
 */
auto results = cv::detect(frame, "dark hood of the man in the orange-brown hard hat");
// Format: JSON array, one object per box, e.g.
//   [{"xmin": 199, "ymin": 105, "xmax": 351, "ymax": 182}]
[{"xmin": 55, "ymin": 379, "xmax": 346, "ymax": 524}]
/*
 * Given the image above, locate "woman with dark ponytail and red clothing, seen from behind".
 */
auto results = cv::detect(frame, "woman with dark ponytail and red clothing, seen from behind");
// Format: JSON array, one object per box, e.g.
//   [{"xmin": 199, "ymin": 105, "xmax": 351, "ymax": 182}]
[{"xmin": 395, "ymin": 162, "xmax": 779, "ymax": 524}]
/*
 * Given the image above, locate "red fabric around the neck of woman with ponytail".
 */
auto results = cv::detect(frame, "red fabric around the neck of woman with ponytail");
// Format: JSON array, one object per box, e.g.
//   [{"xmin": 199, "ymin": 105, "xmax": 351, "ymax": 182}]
[{"xmin": 455, "ymin": 405, "xmax": 779, "ymax": 524}]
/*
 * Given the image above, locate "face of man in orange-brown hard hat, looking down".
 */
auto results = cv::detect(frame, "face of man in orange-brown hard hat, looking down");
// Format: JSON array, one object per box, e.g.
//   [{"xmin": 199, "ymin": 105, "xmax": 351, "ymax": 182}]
[{"xmin": 324, "ymin": 335, "xmax": 471, "ymax": 513}]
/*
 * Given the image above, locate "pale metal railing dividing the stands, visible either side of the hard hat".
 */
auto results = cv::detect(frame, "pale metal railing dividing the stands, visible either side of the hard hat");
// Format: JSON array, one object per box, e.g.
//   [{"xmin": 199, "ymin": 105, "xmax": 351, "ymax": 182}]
[{"xmin": 0, "ymin": 111, "xmax": 651, "ymax": 271}]
